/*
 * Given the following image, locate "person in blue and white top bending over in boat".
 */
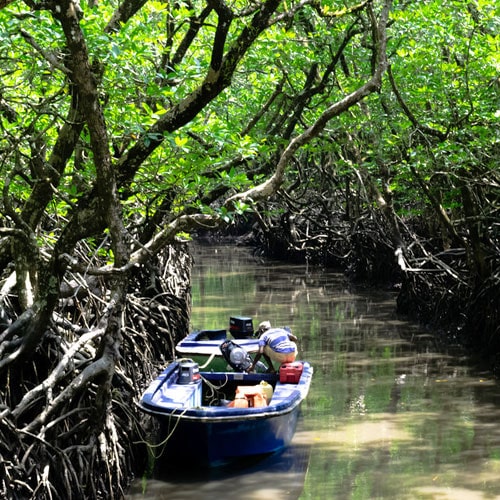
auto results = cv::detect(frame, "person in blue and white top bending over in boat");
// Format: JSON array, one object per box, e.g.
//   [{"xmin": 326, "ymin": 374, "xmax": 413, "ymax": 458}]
[{"xmin": 248, "ymin": 321, "xmax": 297, "ymax": 373}]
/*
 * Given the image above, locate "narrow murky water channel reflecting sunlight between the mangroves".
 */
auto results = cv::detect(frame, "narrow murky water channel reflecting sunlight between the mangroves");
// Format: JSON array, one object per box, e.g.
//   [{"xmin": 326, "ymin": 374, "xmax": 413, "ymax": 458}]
[{"xmin": 127, "ymin": 242, "xmax": 500, "ymax": 500}]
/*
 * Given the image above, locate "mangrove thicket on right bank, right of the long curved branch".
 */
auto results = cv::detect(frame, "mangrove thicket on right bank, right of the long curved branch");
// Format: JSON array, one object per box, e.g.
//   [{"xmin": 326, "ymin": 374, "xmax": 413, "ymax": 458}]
[{"xmin": 243, "ymin": 2, "xmax": 500, "ymax": 352}]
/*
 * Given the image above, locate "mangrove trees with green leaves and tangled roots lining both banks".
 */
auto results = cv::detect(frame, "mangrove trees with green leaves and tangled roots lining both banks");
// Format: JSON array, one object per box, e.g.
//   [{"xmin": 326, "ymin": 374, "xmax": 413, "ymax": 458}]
[{"xmin": 0, "ymin": 0, "xmax": 500, "ymax": 498}]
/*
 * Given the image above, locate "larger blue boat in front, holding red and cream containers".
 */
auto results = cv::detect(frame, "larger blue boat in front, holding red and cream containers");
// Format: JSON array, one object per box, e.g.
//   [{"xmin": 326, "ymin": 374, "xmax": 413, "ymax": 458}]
[{"xmin": 139, "ymin": 360, "xmax": 313, "ymax": 467}]
